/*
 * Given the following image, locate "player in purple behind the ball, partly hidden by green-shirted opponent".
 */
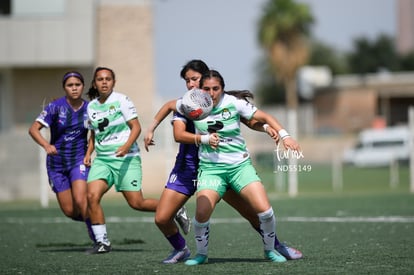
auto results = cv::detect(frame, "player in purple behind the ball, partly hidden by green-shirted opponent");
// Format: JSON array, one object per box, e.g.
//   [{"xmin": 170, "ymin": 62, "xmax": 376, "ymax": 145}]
[{"xmin": 144, "ymin": 60, "xmax": 302, "ymax": 263}]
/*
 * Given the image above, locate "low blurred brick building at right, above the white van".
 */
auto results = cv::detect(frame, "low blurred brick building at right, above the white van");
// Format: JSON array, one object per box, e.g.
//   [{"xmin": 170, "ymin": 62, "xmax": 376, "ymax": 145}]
[{"xmin": 313, "ymin": 72, "xmax": 414, "ymax": 133}]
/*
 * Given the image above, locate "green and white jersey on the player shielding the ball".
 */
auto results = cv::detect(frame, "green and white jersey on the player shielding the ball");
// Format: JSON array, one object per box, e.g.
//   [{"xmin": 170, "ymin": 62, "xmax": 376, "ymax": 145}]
[{"xmin": 194, "ymin": 94, "xmax": 257, "ymax": 168}]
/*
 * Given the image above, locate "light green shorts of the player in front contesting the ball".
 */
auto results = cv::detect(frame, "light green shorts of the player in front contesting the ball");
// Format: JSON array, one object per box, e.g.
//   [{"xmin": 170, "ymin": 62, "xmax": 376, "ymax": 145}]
[{"xmin": 197, "ymin": 159, "xmax": 261, "ymax": 197}]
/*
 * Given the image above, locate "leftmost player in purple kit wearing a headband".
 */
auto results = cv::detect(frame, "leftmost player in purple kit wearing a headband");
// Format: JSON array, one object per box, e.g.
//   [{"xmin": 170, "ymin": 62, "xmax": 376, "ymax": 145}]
[{"xmin": 29, "ymin": 71, "xmax": 95, "ymax": 244}]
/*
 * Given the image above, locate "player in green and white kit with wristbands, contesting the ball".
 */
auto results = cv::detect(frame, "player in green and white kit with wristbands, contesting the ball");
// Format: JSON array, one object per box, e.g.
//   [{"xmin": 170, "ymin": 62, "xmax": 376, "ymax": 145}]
[{"xmin": 183, "ymin": 70, "xmax": 300, "ymax": 265}]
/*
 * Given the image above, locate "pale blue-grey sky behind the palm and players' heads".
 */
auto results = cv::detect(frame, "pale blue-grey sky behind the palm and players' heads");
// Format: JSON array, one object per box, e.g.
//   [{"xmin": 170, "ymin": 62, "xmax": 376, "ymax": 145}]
[{"xmin": 153, "ymin": 0, "xmax": 397, "ymax": 99}]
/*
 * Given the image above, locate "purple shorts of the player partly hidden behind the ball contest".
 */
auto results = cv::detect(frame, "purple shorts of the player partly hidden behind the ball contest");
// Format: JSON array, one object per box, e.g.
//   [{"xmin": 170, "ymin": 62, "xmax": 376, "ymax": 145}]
[{"xmin": 165, "ymin": 170, "xmax": 197, "ymax": 197}]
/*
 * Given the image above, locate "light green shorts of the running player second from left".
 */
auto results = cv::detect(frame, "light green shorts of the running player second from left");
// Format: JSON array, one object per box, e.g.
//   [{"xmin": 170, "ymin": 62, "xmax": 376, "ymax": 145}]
[{"xmin": 88, "ymin": 156, "xmax": 142, "ymax": 192}]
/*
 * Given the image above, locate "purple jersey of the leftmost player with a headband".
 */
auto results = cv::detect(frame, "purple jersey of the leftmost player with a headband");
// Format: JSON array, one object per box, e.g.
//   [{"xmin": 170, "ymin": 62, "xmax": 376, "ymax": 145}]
[{"xmin": 36, "ymin": 96, "xmax": 88, "ymax": 170}]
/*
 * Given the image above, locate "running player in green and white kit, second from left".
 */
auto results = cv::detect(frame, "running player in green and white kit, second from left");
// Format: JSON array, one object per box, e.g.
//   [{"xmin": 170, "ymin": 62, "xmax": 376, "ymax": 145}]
[{"xmin": 85, "ymin": 67, "xmax": 158, "ymax": 254}]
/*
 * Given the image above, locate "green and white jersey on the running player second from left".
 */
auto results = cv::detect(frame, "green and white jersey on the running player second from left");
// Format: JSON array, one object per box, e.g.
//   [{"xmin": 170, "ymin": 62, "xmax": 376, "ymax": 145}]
[{"xmin": 88, "ymin": 91, "xmax": 139, "ymax": 157}]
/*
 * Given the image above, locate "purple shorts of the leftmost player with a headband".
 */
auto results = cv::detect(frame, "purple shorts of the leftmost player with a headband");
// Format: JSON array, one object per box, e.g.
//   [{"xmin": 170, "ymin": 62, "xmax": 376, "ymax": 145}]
[{"xmin": 47, "ymin": 163, "xmax": 89, "ymax": 193}]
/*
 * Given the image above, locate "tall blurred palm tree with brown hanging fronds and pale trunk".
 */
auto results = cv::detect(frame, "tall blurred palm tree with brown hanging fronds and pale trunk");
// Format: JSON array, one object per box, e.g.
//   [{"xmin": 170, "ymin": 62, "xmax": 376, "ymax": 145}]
[{"xmin": 258, "ymin": 0, "xmax": 313, "ymax": 196}]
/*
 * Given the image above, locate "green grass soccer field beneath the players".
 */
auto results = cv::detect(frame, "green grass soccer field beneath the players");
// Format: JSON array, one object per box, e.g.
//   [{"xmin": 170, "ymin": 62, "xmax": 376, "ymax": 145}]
[{"xmin": 0, "ymin": 166, "xmax": 414, "ymax": 274}]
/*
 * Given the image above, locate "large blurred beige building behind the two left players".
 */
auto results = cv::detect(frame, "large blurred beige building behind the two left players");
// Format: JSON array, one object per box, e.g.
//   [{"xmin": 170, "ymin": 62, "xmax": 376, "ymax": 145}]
[{"xmin": 0, "ymin": 0, "xmax": 171, "ymax": 203}]
